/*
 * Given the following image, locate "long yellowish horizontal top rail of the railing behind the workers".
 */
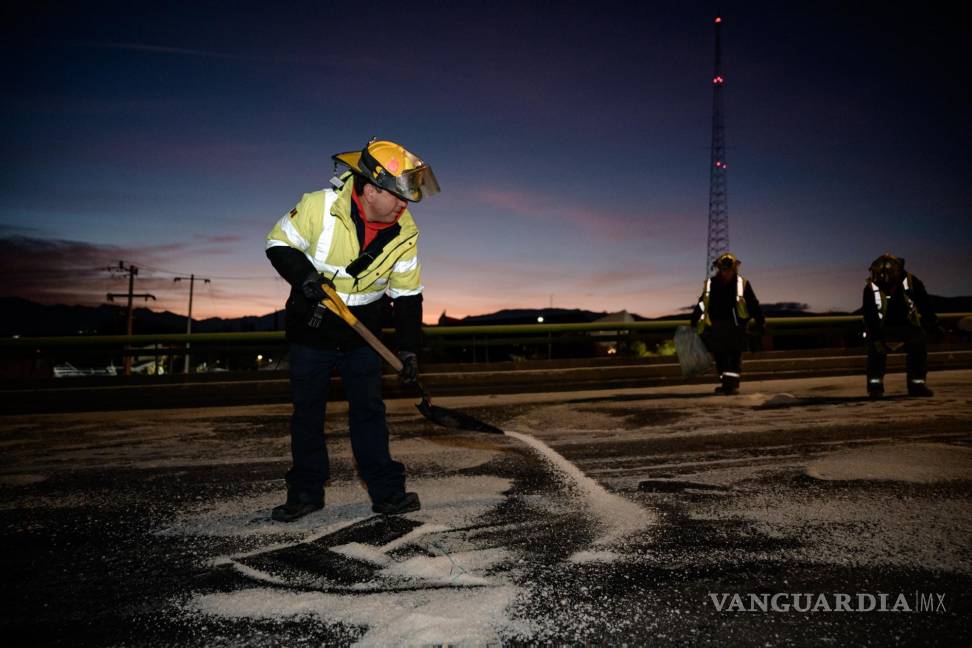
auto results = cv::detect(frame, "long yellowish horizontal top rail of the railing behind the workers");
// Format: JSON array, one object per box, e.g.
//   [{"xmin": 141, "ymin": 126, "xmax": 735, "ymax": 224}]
[{"xmin": 0, "ymin": 313, "xmax": 972, "ymax": 350}]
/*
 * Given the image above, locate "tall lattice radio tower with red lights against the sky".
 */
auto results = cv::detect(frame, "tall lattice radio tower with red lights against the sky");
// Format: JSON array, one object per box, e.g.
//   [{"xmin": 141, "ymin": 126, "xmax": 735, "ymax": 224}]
[{"xmin": 705, "ymin": 16, "xmax": 729, "ymax": 276}]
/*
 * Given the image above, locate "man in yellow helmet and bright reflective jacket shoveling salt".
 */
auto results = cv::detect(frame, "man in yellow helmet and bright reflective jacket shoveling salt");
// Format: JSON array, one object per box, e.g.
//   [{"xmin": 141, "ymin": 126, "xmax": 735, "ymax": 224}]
[{"xmin": 266, "ymin": 140, "xmax": 439, "ymax": 522}]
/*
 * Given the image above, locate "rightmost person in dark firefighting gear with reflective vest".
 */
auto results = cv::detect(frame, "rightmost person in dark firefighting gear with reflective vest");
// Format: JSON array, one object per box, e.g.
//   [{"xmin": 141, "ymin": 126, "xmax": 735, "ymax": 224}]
[{"xmin": 862, "ymin": 252, "xmax": 937, "ymax": 398}]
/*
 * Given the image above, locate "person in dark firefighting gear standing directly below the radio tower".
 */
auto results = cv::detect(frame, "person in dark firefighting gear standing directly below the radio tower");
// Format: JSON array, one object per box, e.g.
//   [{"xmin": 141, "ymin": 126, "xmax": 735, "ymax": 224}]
[{"xmin": 692, "ymin": 252, "xmax": 766, "ymax": 396}]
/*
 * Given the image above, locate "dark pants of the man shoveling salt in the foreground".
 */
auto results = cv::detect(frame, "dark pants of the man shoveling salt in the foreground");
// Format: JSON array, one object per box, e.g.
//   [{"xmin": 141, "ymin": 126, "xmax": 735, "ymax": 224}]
[{"xmin": 287, "ymin": 344, "xmax": 405, "ymax": 502}]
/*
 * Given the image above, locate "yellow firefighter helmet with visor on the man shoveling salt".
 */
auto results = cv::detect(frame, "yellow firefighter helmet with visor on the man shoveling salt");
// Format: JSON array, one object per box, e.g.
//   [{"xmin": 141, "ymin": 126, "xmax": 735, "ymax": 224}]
[{"xmin": 333, "ymin": 140, "xmax": 439, "ymax": 202}]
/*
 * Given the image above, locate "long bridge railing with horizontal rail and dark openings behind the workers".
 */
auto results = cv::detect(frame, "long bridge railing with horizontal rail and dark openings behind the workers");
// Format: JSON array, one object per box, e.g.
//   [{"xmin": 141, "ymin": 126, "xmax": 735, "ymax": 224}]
[{"xmin": 0, "ymin": 313, "xmax": 972, "ymax": 378}]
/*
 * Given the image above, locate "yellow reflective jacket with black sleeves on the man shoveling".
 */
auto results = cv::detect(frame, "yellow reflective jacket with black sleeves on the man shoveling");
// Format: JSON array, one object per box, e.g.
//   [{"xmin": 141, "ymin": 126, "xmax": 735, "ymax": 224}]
[{"xmin": 266, "ymin": 174, "xmax": 422, "ymax": 351}]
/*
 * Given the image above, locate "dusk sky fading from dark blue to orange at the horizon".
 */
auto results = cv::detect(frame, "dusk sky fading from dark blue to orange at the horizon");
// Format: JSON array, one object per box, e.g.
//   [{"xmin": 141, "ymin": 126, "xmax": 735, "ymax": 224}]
[{"xmin": 0, "ymin": 1, "xmax": 972, "ymax": 322}]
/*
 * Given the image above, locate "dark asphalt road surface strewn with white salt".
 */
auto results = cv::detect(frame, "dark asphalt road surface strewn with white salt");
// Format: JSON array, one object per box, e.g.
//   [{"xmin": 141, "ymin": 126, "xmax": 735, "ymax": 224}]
[{"xmin": 0, "ymin": 370, "xmax": 972, "ymax": 646}]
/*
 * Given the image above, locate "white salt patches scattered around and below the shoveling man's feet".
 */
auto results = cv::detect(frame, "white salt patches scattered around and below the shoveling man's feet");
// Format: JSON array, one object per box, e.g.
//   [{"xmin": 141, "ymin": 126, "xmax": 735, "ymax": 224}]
[{"xmin": 187, "ymin": 476, "xmax": 530, "ymax": 646}]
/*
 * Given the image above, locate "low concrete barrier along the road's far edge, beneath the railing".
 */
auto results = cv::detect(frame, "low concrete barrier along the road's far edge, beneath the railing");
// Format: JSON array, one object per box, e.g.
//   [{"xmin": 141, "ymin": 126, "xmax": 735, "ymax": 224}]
[{"xmin": 0, "ymin": 348, "xmax": 972, "ymax": 414}]
